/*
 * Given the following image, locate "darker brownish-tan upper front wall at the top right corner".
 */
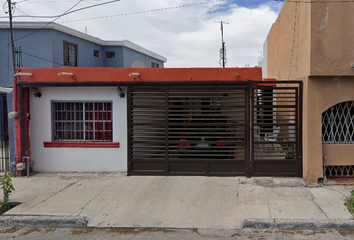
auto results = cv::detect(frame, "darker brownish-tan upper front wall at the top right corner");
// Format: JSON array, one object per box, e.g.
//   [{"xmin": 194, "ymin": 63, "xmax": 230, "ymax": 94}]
[{"xmin": 310, "ymin": 0, "xmax": 354, "ymax": 76}]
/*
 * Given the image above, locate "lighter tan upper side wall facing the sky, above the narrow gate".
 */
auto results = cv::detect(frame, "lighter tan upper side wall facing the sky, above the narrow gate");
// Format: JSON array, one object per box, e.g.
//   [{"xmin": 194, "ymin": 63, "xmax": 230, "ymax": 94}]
[{"xmin": 267, "ymin": 2, "xmax": 311, "ymax": 80}]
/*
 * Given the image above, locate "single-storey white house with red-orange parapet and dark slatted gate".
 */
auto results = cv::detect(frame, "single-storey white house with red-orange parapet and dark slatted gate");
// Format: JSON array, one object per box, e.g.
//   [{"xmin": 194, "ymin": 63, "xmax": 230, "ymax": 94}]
[{"xmin": 14, "ymin": 68, "xmax": 301, "ymax": 177}]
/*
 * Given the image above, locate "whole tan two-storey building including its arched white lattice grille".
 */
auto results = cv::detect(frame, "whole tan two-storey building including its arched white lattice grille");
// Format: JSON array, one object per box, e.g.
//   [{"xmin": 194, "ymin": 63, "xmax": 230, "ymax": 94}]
[{"xmin": 262, "ymin": 1, "xmax": 354, "ymax": 183}]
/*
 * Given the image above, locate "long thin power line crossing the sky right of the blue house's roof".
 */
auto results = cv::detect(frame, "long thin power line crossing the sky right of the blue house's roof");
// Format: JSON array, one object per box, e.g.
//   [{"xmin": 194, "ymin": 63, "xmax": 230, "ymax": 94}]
[{"xmin": 60, "ymin": 0, "xmax": 225, "ymax": 23}]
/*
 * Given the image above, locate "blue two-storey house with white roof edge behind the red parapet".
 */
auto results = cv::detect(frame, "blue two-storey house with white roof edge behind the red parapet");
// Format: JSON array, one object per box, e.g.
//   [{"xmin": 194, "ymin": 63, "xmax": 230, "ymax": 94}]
[{"xmin": 0, "ymin": 22, "xmax": 166, "ymax": 172}]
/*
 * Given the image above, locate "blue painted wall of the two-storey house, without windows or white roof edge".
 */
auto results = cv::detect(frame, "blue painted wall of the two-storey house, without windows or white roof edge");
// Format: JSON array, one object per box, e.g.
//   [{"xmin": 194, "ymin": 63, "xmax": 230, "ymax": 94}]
[{"xmin": 0, "ymin": 29, "xmax": 164, "ymax": 87}]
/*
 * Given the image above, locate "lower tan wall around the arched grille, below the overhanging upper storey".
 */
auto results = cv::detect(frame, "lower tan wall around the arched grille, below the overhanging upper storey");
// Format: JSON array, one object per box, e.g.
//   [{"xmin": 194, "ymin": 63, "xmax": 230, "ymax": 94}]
[{"xmin": 303, "ymin": 77, "xmax": 354, "ymax": 182}]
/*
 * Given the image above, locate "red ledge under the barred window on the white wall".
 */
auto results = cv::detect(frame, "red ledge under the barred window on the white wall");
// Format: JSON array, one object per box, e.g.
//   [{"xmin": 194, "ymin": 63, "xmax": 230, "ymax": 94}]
[{"xmin": 43, "ymin": 142, "xmax": 119, "ymax": 148}]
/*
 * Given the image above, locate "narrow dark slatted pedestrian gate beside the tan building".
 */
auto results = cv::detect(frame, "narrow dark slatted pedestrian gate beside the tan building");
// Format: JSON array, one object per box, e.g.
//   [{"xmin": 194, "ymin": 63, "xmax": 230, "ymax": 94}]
[{"xmin": 250, "ymin": 84, "xmax": 302, "ymax": 177}]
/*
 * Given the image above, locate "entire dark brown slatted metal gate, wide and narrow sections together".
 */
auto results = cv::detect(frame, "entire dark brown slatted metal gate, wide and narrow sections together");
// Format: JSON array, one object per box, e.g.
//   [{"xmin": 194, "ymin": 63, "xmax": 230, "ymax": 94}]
[{"xmin": 128, "ymin": 81, "xmax": 301, "ymax": 176}]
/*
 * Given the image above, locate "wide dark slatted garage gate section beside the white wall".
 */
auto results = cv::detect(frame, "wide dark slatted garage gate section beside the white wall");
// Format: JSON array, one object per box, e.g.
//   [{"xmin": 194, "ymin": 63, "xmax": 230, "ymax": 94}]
[{"xmin": 128, "ymin": 86, "xmax": 247, "ymax": 175}]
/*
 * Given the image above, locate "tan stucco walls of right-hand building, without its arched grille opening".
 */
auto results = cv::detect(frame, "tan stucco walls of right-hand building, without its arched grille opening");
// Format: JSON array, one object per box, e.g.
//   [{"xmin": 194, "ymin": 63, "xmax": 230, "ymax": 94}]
[{"xmin": 267, "ymin": 2, "xmax": 354, "ymax": 183}]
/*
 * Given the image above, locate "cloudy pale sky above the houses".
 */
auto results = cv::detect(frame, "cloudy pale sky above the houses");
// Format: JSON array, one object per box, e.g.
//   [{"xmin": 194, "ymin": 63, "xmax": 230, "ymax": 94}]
[{"xmin": 0, "ymin": 0, "xmax": 284, "ymax": 68}]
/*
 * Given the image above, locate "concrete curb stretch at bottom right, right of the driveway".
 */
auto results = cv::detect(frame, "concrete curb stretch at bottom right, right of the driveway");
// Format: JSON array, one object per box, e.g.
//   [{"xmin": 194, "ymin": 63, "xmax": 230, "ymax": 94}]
[{"xmin": 242, "ymin": 219, "xmax": 354, "ymax": 231}]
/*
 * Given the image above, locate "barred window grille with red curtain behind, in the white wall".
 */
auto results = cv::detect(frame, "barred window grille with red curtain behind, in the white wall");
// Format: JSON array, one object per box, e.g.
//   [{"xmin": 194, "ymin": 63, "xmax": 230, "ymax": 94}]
[{"xmin": 52, "ymin": 101, "xmax": 112, "ymax": 142}]
